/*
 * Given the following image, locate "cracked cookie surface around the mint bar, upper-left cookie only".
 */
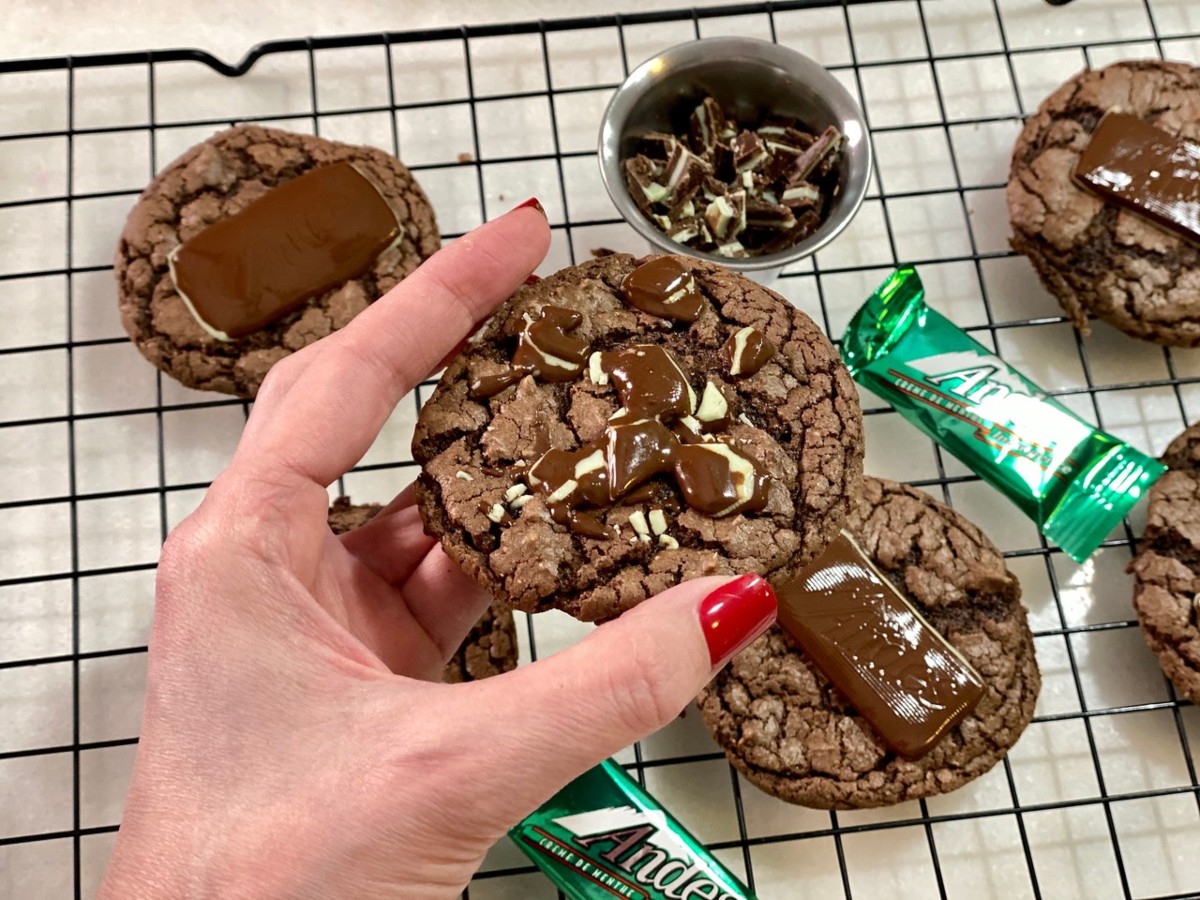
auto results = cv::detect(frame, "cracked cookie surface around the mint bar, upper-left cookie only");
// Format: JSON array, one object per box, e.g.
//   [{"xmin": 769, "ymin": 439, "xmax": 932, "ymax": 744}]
[{"xmin": 116, "ymin": 125, "xmax": 440, "ymax": 397}]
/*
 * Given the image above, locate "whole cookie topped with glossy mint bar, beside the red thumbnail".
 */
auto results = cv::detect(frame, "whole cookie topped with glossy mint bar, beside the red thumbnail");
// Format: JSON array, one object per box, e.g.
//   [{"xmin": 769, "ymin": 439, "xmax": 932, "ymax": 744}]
[{"xmin": 698, "ymin": 478, "xmax": 1042, "ymax": 809}]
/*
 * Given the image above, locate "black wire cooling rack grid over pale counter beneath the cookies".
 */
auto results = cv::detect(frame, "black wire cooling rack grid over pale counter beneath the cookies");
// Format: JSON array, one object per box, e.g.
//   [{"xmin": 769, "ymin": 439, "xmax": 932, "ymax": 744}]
[{"xmin": 0, "ymin": 0, "xmax": 1200, "ymax": 900}]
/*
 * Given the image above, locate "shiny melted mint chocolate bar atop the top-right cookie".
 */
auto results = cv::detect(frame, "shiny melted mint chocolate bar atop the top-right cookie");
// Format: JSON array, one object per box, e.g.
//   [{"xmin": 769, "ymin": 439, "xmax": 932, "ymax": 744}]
[{"xmin": 1075, "ymin": 113, "xmax": 1200, "ymax": 244}]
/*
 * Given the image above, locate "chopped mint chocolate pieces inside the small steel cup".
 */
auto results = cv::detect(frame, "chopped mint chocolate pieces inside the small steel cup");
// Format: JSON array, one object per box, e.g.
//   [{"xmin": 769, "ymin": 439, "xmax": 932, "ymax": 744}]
[{"xmin": 624, "ymin": 97, "xmax": 845, "ymax": 258}]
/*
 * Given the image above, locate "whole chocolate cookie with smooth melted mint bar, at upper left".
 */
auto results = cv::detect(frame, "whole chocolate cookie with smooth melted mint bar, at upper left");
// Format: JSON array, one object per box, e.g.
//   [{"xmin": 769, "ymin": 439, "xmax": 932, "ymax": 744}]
[{"xmin": 116, "ymin": 125, "xmax": 440, "ymax": 397}]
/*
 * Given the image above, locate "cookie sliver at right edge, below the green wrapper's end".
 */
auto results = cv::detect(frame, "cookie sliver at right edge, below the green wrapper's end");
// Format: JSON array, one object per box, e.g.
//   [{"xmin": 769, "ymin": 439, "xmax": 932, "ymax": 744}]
[{"xmin": 1129, "ymin": 422, "xmax": 1200, "ymax": 703}]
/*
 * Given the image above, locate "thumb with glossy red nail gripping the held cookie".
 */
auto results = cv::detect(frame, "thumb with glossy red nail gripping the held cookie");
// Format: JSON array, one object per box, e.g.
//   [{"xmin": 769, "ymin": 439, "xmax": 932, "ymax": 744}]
[{"xmin": 463, "ymin": 575, "xmax": 776, "ymax": 822}]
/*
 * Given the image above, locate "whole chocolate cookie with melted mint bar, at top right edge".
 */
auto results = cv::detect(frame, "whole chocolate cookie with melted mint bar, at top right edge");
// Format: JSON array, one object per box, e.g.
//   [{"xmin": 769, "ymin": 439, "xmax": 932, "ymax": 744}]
[{"xmin": 1008, "ymin": 60, "xmax": 1200, "ymax": 347}]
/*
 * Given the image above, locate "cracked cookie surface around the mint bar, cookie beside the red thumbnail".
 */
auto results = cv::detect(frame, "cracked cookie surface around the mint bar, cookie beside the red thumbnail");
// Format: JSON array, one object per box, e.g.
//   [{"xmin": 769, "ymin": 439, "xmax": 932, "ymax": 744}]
[{"xmin": 698, "ymin": 478, "xmax": 1042, "ymax": 809}]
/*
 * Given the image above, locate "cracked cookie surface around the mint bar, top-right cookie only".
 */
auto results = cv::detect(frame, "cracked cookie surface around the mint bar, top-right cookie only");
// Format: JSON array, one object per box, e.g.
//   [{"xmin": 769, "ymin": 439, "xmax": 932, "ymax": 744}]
[{"xmin": 1008, "ymin": 60, "xmax": 1200, "ymax": 347}]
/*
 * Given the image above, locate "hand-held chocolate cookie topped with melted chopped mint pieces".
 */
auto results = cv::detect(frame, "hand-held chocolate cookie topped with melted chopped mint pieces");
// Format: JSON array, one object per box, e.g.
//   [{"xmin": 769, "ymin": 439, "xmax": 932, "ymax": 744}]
[{"xmin": 413, "ymin": 253, "xmax": 863, "ymax": 622}]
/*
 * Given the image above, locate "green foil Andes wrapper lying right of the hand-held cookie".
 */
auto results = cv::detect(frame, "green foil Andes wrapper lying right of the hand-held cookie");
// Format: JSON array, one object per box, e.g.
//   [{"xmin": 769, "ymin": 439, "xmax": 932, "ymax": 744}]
[{"xmin": 841, "ymin": 269, "xmax": 1165, "ymax": 563}]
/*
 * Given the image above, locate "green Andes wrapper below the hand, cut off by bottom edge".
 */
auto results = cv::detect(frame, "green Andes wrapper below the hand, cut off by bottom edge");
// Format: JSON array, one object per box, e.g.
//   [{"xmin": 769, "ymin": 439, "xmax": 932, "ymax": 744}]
[{"xmin": 509, "ymin": 760, "xmax": 754, "ymax": 900}]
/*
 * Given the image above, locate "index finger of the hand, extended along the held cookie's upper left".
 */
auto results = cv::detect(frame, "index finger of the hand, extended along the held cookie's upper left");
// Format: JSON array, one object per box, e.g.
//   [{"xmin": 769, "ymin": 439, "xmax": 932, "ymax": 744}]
[{"xmin": 233, "ymin": 205, "xmax": 550, "ymax": 487}]
